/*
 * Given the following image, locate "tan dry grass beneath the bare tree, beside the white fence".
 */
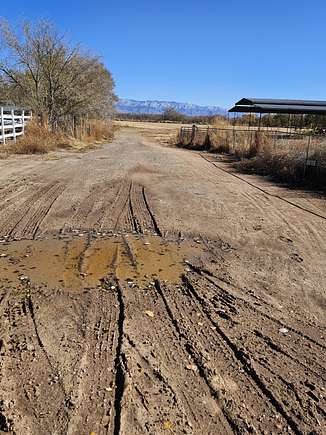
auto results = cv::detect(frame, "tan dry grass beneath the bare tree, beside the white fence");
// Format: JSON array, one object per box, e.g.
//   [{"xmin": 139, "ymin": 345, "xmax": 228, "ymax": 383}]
[{"xmin": 3, "ymin": 120, "xmax": 115, "ymax": 155}]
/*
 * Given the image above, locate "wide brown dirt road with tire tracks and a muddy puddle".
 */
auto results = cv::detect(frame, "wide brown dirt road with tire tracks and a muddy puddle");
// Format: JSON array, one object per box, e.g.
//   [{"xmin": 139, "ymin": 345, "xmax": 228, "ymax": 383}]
[{"xmin": 0, "ymin": 130, "xmax": 326, "ymax": 435}]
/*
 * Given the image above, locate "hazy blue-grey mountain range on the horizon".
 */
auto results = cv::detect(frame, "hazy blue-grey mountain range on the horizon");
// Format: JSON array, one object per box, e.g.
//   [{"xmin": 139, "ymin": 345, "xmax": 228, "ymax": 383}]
[{"xmin": 116, "ymin": 99, "xmax": 226, "ymax": 116}]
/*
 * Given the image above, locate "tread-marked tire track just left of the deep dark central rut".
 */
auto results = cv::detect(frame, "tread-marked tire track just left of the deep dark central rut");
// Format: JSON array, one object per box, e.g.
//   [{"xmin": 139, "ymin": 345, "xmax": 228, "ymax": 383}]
[{"xmin": 67, "ymin": 281, "xmax": 118, "ymax": 435}]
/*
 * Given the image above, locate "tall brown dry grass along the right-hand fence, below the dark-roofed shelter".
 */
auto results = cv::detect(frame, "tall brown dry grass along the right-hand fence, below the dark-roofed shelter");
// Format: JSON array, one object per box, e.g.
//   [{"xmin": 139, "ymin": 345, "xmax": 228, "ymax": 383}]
[{"xmin": 178, "ymin": 127, "xmax": 326, "ymax": 185}]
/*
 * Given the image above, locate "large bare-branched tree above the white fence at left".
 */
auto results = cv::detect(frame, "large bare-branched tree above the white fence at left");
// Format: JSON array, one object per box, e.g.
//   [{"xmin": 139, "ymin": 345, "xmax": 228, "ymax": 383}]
[{"xmin": 0, "ymin": 21, "xmax": 115, "ymax": 128}]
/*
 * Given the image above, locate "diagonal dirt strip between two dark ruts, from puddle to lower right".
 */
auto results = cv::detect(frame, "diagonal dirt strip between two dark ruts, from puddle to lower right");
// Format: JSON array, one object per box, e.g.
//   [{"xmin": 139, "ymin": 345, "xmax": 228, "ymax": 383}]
[{"xmin": 150, "ymin": 285, "xmax": 298, "ymax": 433}]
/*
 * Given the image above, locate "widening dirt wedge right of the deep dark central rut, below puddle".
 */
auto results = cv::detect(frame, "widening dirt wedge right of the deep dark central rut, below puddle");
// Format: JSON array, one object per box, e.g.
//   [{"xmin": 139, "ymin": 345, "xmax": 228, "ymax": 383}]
[{"xmin": 122, "ymin": 280, "xmax": 233, "ymax": 435}]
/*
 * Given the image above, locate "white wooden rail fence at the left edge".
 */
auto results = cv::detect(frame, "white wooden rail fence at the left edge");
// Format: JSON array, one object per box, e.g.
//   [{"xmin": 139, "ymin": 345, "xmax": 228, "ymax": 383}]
[{"xmin": 0, "ymin": 106, "xmax": 32, "ymax": 144}]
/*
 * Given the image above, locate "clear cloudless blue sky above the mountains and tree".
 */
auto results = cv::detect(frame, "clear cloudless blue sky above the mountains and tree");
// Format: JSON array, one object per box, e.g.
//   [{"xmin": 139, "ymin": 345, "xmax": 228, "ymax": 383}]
[{"xmin": 0, "ymin": 0, "xmax": 326, "ymax": 107}]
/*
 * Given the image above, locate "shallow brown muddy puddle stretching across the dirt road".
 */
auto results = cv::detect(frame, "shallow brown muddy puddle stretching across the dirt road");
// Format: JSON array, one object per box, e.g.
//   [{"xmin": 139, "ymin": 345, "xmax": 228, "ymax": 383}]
[{"xmin": 0, "ymin": 234, "xmax": 201, "ymax": 291}]
